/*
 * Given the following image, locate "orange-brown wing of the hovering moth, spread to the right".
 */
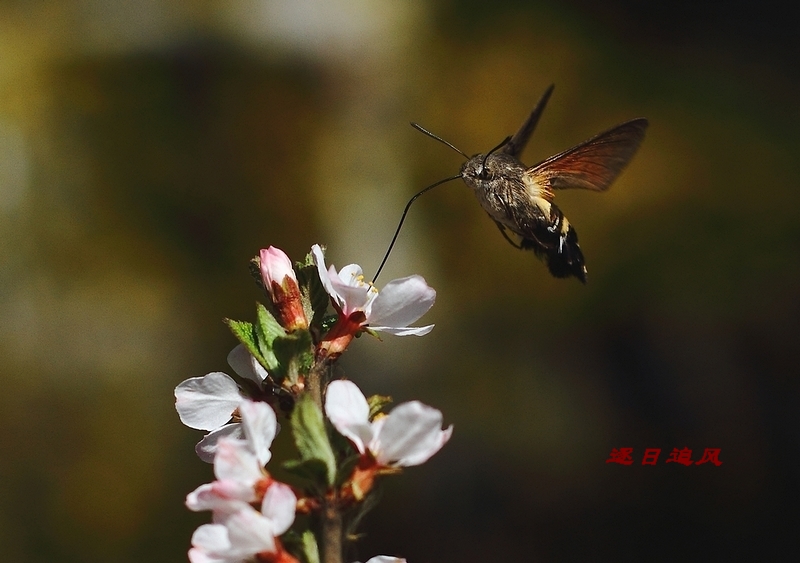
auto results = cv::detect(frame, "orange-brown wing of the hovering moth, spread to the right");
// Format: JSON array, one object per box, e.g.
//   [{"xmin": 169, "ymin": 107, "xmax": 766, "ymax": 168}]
[{"xmin": 526, "ymin": 118, "xmax": 647, "ymax": 192}]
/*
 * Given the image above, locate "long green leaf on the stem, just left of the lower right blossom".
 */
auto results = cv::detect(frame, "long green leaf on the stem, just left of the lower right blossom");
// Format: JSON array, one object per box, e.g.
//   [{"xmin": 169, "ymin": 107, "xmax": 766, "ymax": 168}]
[{"xmin": 291, "ymin": 394, "xmax": 336, "ymax": 486}]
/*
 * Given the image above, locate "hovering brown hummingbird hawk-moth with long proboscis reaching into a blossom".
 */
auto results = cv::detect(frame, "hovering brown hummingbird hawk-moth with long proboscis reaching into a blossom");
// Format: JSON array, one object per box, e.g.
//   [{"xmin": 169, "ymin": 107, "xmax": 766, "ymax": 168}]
[{"xmin": 375, "ymin": 85, "xmax": 647, "ymax": 283}]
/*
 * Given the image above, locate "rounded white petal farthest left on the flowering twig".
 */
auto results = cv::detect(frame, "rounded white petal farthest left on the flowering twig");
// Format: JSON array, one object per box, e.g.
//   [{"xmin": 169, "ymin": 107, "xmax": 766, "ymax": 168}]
[{"xmin": 175, "ymin": 371, "xmax": 242, "ymax": 430}]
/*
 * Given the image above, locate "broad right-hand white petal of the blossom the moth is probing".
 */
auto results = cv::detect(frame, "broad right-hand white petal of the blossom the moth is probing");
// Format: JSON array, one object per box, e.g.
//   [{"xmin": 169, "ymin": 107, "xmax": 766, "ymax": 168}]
[{"xmin": 367, "ymin": 276, "xmax": 436, "ymax": 328}]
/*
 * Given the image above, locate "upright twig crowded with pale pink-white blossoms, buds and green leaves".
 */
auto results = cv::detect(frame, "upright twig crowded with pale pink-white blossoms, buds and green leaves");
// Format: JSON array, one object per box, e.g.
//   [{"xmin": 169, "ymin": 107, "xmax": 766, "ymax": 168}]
[{"xmin": 175, "ymin": 245, "xmax": 452, "ymax": 563}]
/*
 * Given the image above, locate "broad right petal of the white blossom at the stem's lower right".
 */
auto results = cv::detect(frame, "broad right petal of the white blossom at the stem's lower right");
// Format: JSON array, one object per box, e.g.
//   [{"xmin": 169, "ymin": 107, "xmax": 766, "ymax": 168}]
[{"xmin": 370, "ymin": 401, "xmax": 453, "ymax": 467}]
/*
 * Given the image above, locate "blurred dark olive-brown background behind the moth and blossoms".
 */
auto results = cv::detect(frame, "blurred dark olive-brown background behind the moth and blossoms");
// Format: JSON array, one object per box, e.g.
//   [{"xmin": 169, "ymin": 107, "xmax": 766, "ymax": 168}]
[{"xmin": 0, "ymin": 0, "xmax": 800, "ymax": 563}]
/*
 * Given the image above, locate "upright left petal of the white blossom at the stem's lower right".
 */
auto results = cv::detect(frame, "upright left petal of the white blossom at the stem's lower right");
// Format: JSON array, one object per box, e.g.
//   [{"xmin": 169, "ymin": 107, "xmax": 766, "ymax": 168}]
[{"xmin": 325, "ymin": 380, "xmax": 372, "ymax": 454}]
